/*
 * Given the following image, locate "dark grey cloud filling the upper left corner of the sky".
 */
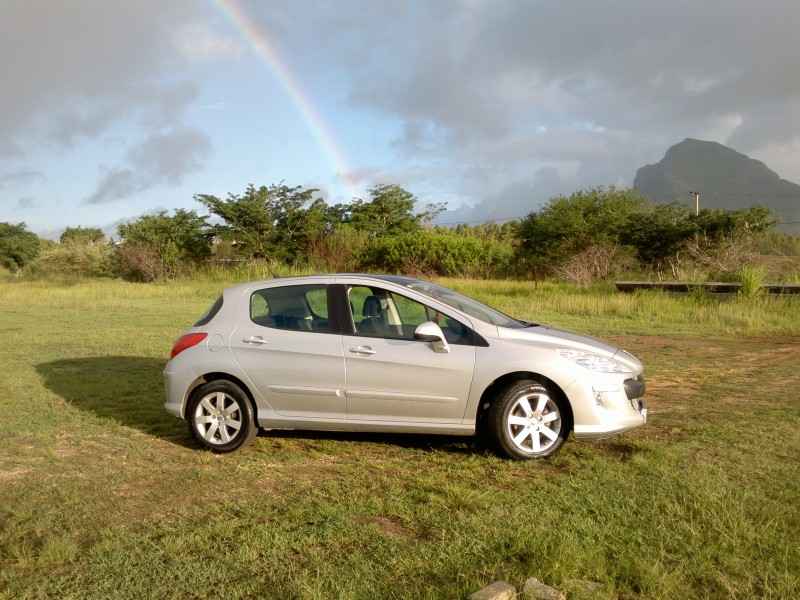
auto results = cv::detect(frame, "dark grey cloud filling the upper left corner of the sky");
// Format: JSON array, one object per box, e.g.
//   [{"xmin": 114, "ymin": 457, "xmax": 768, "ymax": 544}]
[{"xmin": 0, "ymin": 0, "xmax": 192, "ymax": 148}]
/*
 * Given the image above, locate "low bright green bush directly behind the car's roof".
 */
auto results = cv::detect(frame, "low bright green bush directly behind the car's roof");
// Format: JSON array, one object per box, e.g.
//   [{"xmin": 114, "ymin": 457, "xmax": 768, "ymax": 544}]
[{"xmin": 363, "ymin": 230, "xmax": 513, "ymax": 276}]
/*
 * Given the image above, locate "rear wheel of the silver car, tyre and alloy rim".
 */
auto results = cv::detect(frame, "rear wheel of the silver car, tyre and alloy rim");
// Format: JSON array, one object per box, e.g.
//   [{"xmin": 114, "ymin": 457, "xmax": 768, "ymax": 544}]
[{"xmin": 186, "ymin": 380, "xmax": 257, "ymax": 452}]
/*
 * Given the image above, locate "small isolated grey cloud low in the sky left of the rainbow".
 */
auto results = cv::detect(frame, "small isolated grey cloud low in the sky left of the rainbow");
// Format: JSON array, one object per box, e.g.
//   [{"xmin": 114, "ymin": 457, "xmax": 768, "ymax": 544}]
[{"xmin": 85, "ymin": 128, "xmax": 211, "ymax": 204}]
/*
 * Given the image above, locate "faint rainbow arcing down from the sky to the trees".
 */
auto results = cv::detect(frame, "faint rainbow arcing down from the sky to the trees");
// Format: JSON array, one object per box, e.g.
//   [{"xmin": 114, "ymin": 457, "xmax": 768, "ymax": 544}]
[{"xmin": 210, "ymin": 0, "xmax": 360, "ymax": 202}]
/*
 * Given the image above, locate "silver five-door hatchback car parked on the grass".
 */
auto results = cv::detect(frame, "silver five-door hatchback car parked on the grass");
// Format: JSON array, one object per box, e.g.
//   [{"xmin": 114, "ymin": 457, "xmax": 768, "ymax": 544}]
[{"xmin": 164, "ymin": 275, "xmax": 647, "ymax": 459}]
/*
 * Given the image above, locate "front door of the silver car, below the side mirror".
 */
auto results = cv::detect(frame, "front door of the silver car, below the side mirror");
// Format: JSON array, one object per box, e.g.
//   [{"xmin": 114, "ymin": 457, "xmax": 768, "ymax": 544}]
[{"xmin": 343, "ymin": 286, "xmax": 475, "ymax": 424}]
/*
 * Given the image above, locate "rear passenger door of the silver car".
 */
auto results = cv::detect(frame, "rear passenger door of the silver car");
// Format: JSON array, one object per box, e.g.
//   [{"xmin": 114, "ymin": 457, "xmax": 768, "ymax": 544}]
[{"xmin": 231, "ymin": 284, "xmax": 346, "ymax": 419}]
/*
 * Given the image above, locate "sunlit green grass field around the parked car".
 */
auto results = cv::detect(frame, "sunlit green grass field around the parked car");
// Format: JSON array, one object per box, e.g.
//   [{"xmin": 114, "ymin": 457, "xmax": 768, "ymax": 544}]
[{"xmin": 0, "ymin": 280, "xmax": 800, "ymax": 599}]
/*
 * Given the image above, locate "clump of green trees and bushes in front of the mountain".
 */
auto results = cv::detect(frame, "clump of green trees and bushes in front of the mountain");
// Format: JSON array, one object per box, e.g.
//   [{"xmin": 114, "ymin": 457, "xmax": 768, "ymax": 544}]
[{"xmin": 519, "ymin": 186, "xmax": 776, "ymax": 283}]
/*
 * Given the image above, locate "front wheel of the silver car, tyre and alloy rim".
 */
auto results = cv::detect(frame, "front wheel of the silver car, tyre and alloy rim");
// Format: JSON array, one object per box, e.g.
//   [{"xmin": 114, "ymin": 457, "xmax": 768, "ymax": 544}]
[{"xmin": 488, "ymin": 380, "xmax": 570, "ymax": 460}]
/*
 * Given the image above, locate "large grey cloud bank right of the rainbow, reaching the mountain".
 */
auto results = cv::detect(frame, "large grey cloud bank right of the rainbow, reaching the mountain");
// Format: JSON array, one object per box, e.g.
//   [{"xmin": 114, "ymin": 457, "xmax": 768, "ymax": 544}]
[{"xmin": 274, "ymin": 0, "xmax": 800, "ymax": 217}]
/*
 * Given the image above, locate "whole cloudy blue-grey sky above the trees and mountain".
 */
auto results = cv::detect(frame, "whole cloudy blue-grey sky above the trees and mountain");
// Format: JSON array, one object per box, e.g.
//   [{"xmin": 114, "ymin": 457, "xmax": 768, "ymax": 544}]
[{"xmin": 0, "ymin": 0, "xmax": 800, "ymax": 240}]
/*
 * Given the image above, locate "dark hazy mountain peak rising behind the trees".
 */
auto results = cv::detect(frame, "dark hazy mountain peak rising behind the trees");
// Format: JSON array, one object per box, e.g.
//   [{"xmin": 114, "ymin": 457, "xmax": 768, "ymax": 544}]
[{"xmin": 633, "ymin": 138, "xmax": 800, "ymax": 235}]
